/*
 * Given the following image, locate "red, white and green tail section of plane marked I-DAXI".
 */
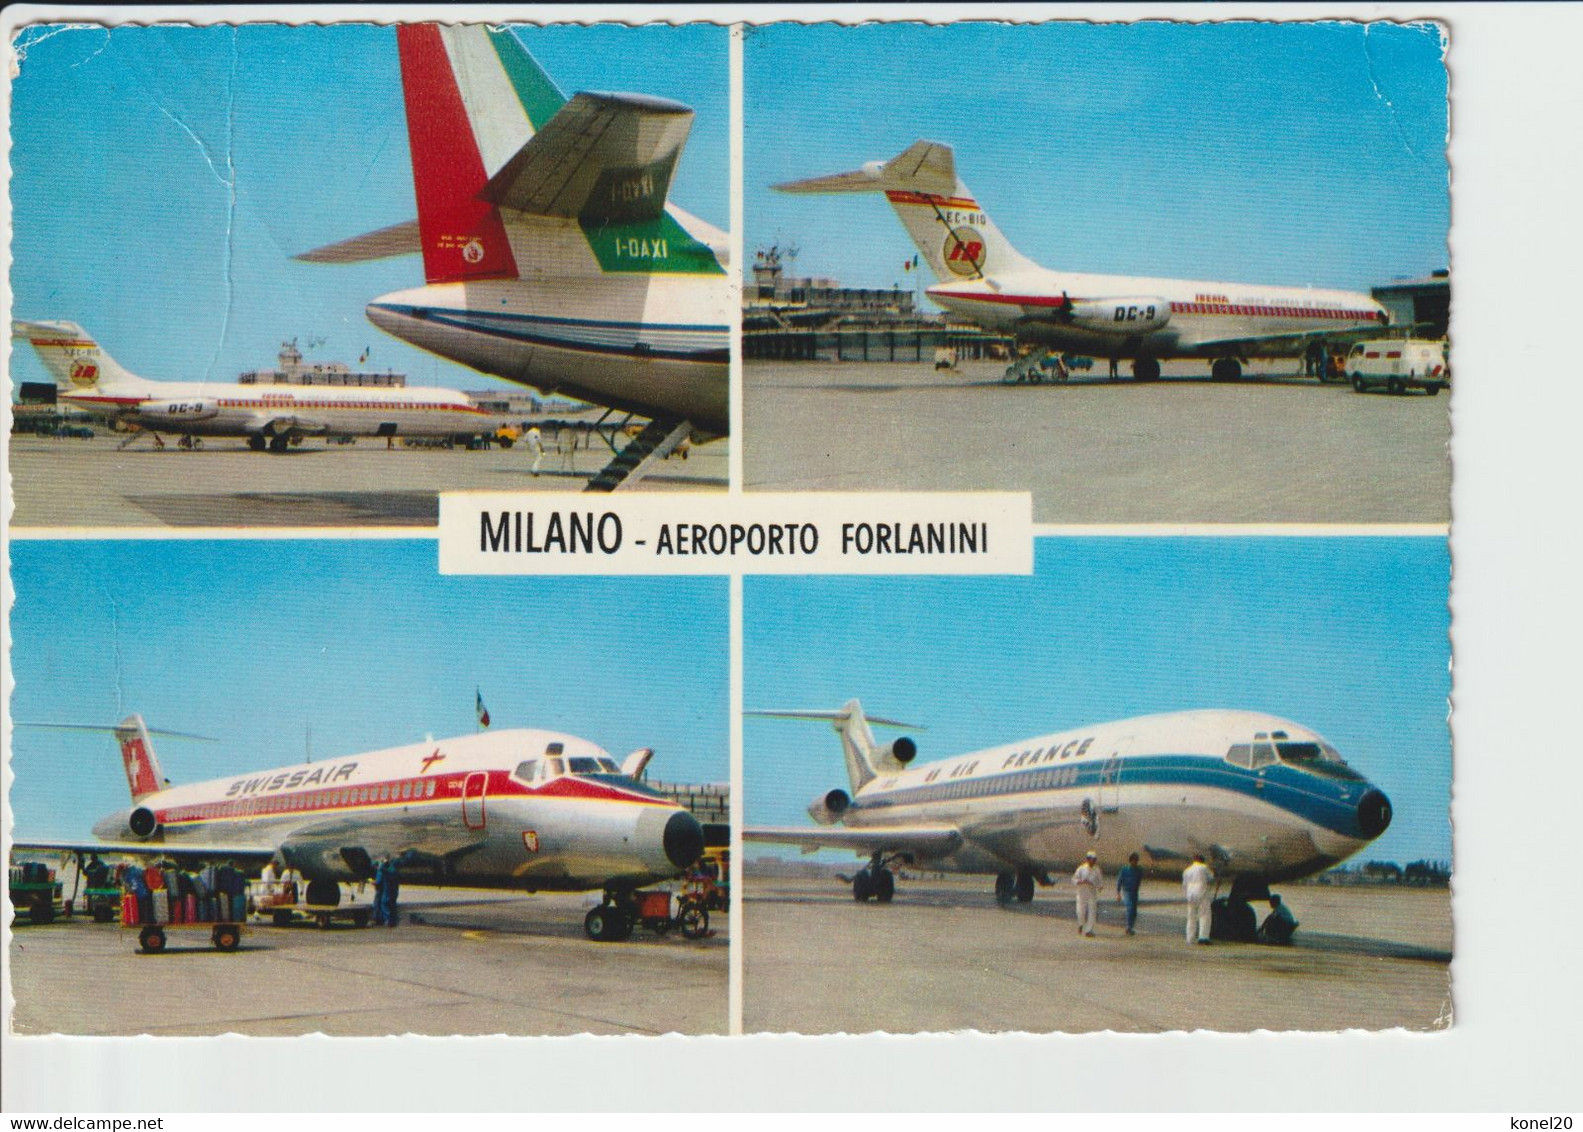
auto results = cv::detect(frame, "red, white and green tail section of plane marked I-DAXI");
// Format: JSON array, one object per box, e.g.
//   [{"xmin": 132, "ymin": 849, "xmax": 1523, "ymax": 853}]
[{"xmin": 298, "ymin": 24, "xmax": 731, "ymax": 491}]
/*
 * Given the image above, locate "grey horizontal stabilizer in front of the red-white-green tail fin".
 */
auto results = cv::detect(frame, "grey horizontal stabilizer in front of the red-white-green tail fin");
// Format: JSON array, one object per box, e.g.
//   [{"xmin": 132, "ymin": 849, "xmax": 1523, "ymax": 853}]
[{"xmin": 478, "ymin": 92, "xmax": 693, "ymax": 223}]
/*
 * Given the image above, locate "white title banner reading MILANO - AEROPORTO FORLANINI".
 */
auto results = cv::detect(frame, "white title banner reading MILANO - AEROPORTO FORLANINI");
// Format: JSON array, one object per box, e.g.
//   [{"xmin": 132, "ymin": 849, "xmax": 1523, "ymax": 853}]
[{"xmin": 440, "ymin": 491, "xmax": 1034, "ymax": 575}]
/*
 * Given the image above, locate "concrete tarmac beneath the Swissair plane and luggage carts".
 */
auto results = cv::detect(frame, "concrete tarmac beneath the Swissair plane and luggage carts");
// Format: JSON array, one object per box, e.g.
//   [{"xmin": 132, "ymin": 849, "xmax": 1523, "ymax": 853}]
[{"xmin": 11, "ymin": 885, "xmax": 730, "ymax": 1035}]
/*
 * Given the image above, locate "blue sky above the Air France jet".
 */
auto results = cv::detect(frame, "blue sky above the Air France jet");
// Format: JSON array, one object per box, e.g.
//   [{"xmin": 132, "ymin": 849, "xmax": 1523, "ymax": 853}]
[{"xmin": 742, "ymin": 538, "xmax": 1452, "ymax": 863}]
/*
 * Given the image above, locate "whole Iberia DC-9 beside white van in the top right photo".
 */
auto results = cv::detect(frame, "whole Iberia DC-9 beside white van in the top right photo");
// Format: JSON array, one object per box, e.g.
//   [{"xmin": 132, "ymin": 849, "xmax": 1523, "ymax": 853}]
[{"xmin": 776, "ymin": 141, "xmax": 1390, "ymax": 382}]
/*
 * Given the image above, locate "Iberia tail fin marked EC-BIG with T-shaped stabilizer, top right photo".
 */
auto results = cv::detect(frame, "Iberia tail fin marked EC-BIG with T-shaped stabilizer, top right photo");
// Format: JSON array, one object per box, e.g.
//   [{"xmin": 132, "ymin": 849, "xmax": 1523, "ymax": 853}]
[{"xmin": 776, "ymin": 139, "xmax": 1035, "ymax": 282}]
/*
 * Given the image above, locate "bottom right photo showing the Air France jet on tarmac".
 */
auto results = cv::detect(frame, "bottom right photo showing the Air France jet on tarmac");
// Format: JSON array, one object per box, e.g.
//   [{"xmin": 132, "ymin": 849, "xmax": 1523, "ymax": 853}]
[{"xmin": 741, "ymin": 535, "xmax": 1453, "ymax": 1034}]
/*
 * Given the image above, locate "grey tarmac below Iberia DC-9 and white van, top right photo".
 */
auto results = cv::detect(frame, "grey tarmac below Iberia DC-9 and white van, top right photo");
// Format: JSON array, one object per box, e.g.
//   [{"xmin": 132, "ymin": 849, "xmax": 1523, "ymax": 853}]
[{"xmin": 742, "ymin": 359, "xmax": 1452, "ymax": 524}]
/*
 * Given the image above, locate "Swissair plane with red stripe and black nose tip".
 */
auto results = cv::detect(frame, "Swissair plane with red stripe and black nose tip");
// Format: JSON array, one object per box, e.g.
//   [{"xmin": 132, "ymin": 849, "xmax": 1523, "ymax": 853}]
[{"xmin": 14, "ymin": 716, "xmax": 704, "ymax": 942}]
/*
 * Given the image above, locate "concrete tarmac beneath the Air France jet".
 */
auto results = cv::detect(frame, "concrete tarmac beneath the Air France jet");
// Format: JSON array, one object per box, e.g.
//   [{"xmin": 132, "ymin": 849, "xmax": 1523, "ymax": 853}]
[{"xmin": 742, "ymin": 866, "xmax": 1452, "ymax": 1034}]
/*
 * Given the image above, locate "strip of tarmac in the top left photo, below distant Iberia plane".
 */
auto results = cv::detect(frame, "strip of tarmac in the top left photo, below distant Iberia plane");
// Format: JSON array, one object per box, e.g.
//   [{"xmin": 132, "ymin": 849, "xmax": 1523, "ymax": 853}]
[{"xmin": 9, "ymin": 432, "xmax": 730, "ymax": 527}]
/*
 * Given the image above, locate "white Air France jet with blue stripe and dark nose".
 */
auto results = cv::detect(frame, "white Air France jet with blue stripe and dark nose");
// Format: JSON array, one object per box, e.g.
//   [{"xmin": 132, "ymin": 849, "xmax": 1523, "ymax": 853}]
[{"xmin": 742, "ymin": 700, "xmax": 1391, "ymax": 904}]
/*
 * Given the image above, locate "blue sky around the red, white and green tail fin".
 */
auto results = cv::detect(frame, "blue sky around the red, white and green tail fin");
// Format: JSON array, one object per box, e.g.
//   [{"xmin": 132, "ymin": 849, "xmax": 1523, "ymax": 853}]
[{"xmin": 11, "ymin": 24, "xmax": 730, "ymax": 388}]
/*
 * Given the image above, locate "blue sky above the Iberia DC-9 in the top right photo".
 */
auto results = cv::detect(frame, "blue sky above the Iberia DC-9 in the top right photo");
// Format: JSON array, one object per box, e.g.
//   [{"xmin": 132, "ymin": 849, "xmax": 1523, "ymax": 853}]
[{"xmin": 744, "ymin": 22, "xmax": 1450, "ymax": 296}]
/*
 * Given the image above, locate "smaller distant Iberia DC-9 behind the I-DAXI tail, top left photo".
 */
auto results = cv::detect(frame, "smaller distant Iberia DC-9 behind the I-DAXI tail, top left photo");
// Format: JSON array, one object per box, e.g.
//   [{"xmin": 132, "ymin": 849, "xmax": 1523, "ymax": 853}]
[{"xmin": 11, "ymin": 320, "xmax": 491, "ymax": 453}]
